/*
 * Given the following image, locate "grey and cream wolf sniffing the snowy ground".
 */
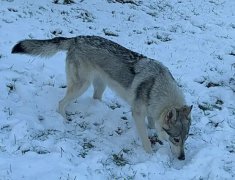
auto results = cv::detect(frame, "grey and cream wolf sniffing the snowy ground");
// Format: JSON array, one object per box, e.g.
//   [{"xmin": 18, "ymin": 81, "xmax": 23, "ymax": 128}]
[{"xmin": 12, "ymin": 36, "xmax": 192, "ymax": 160}]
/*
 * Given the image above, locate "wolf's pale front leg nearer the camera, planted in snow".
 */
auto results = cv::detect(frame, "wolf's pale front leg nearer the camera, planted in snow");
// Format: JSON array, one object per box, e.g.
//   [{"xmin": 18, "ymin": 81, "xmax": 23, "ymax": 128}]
[{"xmin": 132, "ymin": 107, "xmax": 153, "ymax": 153}]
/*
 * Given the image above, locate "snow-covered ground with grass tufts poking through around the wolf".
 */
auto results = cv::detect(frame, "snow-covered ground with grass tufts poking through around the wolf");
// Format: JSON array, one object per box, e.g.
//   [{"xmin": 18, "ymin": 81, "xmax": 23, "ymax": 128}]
[{"xmin": 0, "ymin": 0, "xmax": 235, "ymax": 180}]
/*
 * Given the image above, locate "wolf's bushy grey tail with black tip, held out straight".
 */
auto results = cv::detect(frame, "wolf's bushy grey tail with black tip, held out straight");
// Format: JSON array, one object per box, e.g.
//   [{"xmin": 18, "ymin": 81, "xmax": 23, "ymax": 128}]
[{"xmin": 11, "ymin": 37, "xmax": 73, "ymax": 57}]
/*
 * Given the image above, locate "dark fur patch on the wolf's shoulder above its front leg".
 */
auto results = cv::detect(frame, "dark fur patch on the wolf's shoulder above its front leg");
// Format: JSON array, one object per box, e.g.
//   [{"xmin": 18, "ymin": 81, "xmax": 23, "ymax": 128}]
[{"xmin": 136, "ymin": 77, "xmax": 155, "ymax": 102}]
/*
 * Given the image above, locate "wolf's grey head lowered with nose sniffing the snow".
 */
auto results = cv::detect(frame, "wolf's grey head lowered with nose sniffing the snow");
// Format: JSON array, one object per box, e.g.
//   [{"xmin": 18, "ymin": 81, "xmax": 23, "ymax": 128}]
[{"xmin": 162, "ymin": 105, "xmax": 193, "ymax": 160}]
